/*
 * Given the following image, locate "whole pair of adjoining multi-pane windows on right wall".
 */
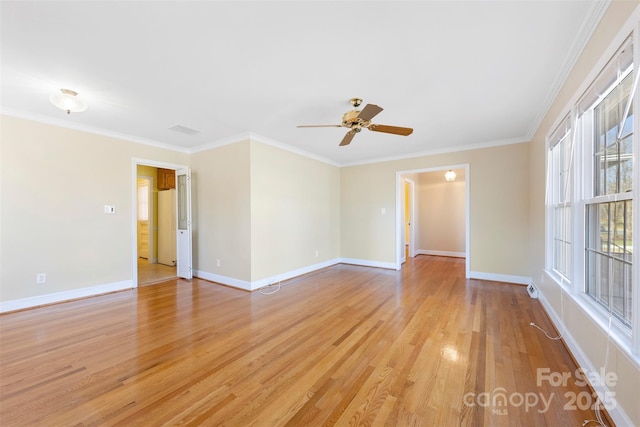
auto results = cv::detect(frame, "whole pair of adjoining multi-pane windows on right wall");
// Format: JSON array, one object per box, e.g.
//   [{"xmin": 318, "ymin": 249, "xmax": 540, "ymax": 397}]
[{"xmin": 547, "ymin": 31, "xmax": 640, "ymax": 336}]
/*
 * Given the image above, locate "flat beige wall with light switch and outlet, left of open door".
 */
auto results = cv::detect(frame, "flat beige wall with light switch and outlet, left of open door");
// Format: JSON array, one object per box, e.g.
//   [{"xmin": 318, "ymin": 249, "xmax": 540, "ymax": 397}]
[{"xmin": 0, "ymin": 116, "xmax": 189, "ymax": 301}]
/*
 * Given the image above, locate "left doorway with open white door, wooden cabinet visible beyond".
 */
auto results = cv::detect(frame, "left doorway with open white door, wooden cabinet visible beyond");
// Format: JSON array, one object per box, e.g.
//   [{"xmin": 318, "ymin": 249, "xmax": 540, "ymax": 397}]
[{"xmin": 133, "ymin": 159, "xmax": 192, "ymax": 286}]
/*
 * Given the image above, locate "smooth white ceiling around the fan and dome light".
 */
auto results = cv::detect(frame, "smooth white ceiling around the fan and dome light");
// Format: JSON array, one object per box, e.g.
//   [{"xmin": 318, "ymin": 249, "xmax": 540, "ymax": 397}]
[{"xmin": 0, "ymin": 0, "xmax": 608, "ymax": 165}]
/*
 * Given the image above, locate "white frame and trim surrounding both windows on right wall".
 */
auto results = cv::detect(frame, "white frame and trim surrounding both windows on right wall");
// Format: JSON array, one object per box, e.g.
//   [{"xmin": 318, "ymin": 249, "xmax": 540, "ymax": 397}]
[{"xmin": 545, "ymin": 23, "xmax": 640, "ymax": 358}]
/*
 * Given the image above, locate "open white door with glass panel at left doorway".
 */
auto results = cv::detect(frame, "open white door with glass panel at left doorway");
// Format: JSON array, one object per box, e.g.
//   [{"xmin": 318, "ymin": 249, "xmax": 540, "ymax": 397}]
[{"xmin": 176, "ymin": 168, "xmax": 193, "ymax": 279}]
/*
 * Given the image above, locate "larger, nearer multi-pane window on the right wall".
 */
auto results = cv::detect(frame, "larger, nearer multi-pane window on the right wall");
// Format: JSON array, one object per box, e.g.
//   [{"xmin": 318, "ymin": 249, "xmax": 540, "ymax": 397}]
[{"xmin": 577, "ymin": 39, "xmax": 633, "ymax": 327}]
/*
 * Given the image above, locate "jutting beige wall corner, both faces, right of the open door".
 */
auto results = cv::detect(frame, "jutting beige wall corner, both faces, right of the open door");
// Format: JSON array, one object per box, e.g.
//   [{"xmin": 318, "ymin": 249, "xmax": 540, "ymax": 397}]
[{"xmin": 192, "ymin": 140, "xmax": 340, "ymax": 289}]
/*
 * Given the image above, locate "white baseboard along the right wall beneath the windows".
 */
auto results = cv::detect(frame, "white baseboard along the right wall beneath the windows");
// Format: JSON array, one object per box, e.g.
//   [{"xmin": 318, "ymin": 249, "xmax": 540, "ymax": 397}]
[{"xmin": 538, "ymin": 290, "xmax": 633, "ymax": 426}]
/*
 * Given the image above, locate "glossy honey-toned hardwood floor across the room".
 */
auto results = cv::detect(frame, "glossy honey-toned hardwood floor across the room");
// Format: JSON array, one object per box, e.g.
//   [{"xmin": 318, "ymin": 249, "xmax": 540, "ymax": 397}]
[{"xmin": 0, "ymin": 256, "xmax": 608, "ymax": 426}]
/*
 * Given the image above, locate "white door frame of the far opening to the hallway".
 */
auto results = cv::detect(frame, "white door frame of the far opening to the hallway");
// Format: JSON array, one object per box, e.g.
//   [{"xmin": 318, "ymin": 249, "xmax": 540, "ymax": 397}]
[{"xmin": 396, "ymin": 163, "xmax": 471, "ymax": 278}]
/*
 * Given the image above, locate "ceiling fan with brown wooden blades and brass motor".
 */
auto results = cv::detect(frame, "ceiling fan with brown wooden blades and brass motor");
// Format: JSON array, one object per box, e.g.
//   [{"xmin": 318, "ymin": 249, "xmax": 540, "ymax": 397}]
[{"xmin": 298, "ymin": 98, "xmax": 413, "ymax": 147}]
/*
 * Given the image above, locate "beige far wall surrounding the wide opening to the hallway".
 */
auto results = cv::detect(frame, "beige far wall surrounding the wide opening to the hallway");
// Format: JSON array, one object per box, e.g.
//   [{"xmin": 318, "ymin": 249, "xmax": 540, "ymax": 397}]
[{"xmin": 340, "ymin": 143, "xmax": 531, "ymax": 280}]
